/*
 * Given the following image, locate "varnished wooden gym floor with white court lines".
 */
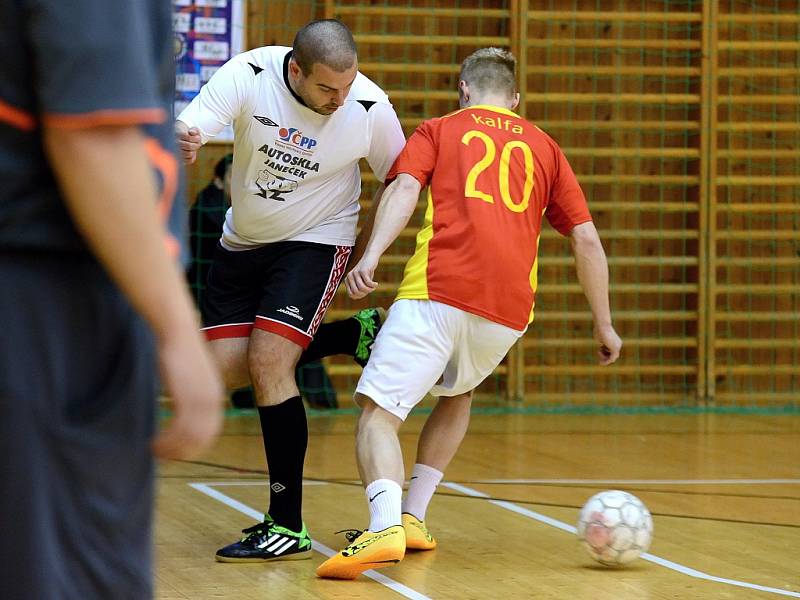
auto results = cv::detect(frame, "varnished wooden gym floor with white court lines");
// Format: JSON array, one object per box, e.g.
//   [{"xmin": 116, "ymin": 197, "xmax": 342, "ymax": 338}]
[{"xmin": 156, "ymin": 407, "xmax": 800, "ymax": 600}]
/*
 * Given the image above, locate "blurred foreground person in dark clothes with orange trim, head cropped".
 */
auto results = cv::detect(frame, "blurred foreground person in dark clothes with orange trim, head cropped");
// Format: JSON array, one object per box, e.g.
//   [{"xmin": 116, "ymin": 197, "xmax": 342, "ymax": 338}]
[{"xmin": 0, "ymin": 0, "xmax": 223, "ymax": 600}]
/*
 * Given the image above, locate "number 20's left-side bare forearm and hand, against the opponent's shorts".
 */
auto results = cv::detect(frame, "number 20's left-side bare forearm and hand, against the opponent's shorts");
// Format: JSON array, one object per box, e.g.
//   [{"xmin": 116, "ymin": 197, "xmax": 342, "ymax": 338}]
[{"xmin": 345, "ymin": 173, "xmax": 422, "ymax": 300}]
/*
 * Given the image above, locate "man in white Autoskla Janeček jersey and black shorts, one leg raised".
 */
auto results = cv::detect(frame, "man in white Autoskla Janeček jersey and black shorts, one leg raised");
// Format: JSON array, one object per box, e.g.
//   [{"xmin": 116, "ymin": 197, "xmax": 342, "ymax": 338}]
[{"xmin": 176, "ymin": 20, "xmax": 405, "ymax": 562}]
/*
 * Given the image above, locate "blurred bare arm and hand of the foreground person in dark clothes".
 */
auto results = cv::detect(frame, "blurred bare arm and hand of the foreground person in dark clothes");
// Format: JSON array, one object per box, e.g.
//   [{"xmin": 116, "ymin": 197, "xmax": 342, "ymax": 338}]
[{"xmin": 43, "ymin": 126, "xmax": 222, "ymax": 458}]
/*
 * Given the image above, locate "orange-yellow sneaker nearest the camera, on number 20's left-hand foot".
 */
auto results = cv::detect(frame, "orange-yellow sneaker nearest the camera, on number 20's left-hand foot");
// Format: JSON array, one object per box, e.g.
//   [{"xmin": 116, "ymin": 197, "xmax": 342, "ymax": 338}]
[{"xmin": 317, "ymin": 525, "xmax": 406, "ymax": 579}]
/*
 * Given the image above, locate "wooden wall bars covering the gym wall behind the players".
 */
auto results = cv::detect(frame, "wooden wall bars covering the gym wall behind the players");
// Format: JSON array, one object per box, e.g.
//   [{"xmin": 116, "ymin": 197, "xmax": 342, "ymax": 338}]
[{"xmin": 184, "ymin": 0, "xmax": 800, "ymax": 410}]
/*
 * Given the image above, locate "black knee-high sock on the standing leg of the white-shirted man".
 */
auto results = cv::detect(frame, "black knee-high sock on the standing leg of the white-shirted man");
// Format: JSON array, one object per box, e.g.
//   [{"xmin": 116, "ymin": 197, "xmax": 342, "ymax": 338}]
[{"xmin": 258, "ymin": 396, "xmax": 308, "ymax": 531}]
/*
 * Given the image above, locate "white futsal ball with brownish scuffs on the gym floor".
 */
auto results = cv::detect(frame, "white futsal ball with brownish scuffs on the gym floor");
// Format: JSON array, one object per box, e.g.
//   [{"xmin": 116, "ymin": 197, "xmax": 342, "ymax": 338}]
[{"xmin": 577, "ymin": 490, "xmax": 653, "ymax": 566}]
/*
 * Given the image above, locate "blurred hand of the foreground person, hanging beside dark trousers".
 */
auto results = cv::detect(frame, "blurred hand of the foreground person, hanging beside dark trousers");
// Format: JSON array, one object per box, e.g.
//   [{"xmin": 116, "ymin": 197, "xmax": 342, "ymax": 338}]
[{"xmin": 153, "ymin": 330, "xmax": 224, "ymax": 459}]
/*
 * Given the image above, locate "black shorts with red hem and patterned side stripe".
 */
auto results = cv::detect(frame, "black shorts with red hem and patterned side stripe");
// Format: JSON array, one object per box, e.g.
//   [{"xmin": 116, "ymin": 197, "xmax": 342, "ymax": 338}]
[{"xmin": 201, "ymin": 241, "xmax": 352, "ymax": 349}]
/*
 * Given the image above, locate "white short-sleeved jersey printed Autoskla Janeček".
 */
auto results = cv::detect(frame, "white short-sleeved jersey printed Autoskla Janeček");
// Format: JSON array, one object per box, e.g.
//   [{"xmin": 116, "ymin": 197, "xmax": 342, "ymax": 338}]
[{"xmin": 178, "ymin": 46, "xmax": 405, "ymax": 250}]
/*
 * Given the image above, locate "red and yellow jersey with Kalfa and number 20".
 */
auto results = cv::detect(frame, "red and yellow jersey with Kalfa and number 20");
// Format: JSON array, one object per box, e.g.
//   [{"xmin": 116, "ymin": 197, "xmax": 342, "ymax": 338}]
[{"xmin": 387, "ymin": 105, "xmax": 592, "ymax": 330}]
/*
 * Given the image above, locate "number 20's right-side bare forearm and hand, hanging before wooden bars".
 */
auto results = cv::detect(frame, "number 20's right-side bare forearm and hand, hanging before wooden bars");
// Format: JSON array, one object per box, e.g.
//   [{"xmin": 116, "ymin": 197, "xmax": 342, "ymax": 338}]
[{"xmin": 569, "ymin": 222, "xmax": 622, "ymax": 365}]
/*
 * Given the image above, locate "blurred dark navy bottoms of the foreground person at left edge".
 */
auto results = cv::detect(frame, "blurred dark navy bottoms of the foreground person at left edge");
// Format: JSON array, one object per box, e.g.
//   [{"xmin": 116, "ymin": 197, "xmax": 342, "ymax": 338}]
[{"xmin": 0, "ymin": 251, "xmax": 157, "ymax": 600}]
